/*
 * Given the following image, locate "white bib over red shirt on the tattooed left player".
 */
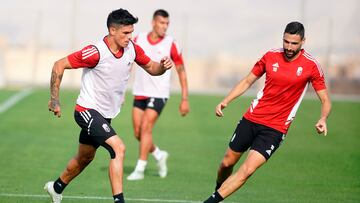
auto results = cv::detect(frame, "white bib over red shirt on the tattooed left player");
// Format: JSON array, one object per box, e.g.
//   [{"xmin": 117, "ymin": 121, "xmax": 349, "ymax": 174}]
[{"xmin": 67, "ymin": 37, "xmax": 150, "ymax": 118}]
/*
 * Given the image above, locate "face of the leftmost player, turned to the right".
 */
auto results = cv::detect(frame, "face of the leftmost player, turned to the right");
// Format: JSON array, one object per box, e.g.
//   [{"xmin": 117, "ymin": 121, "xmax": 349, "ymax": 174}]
[{"xmin": 110, "ymin": 25, "xmax": 134, "ymax": 48}]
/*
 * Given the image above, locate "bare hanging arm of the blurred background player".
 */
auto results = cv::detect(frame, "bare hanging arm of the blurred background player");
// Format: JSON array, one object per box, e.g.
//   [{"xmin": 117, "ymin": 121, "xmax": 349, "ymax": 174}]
[{"xmin": 176, "ymin": 64, "xmax": 190, "ymax": 116}]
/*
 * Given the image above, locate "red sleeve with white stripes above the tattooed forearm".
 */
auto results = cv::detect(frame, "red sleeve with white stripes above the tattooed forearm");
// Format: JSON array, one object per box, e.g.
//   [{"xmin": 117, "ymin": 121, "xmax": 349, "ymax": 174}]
[{"xmin": 67, "ymin": 45, "xmax": 100, "ymax": 68}]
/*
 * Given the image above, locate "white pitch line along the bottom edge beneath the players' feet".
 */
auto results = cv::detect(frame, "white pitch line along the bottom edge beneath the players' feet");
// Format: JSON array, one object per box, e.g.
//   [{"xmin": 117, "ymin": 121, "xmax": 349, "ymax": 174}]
[{"xmin": 0, "ymin": 193, "xmax": 201, "ymax": 203}]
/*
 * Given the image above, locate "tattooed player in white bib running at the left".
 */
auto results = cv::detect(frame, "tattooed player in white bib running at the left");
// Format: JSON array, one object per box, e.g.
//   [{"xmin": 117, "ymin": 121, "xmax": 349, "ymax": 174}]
[{"xmin": 44, "ymin": 9, "xmax": 174, "ymax": 203}]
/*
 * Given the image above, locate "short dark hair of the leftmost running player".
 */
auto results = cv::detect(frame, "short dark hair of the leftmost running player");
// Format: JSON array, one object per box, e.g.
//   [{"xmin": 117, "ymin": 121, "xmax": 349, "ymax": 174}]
[{"xmin": 106, "ymin": 8, "xmax": 138, "ymax": 29}]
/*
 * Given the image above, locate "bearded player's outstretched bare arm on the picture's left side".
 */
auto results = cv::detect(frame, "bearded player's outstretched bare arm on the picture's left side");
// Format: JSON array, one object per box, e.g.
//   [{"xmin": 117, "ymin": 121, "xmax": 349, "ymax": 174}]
[{"xmin": 215, "ymin": 72, "xmax": 259, "ymax": 117}]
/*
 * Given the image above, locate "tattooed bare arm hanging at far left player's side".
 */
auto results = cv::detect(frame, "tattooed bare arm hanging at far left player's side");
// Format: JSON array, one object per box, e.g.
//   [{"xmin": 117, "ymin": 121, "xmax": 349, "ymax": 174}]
[{"xmin": 48, "ymin": 57, "xmax": 71, "ymax": 117}]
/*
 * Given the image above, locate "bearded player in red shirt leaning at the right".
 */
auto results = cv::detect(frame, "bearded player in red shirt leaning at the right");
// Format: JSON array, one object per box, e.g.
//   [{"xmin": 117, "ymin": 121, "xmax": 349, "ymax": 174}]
[{"xmin": 204, "ymin": 22, "xmax": 331, "ymax": 203}]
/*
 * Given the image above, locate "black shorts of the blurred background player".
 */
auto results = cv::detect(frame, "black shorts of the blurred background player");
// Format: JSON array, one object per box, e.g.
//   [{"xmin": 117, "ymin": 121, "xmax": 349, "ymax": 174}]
[{"xmin": 133, "ymin": 97, "xmax": 167, "ymax": 115}]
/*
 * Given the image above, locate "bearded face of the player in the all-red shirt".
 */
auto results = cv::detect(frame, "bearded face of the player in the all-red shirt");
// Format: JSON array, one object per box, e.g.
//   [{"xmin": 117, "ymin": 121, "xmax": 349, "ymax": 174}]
[{"xmin": 283, "ymin": 33, "xmax": 305, "ymax": 61}]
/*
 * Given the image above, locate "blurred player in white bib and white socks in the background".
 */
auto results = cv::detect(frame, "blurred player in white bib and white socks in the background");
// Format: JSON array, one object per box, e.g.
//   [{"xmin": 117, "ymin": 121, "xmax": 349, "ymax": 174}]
[{"xmin": 127, "ymin": 9, "xmax": 189, "ymax": 180}]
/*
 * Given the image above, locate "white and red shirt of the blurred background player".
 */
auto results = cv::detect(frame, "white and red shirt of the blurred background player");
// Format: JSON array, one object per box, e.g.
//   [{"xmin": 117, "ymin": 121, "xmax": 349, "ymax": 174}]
[{"xmin": 133, "ymin": 33, "xmax": 183, "ymax": 98}]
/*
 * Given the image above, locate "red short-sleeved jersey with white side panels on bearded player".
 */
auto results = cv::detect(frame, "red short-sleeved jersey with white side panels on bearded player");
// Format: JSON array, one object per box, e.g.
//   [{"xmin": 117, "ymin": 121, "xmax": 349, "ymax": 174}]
[{"xmin": 244, "ymin": 49, "xmax": 326, "ymax": 133}]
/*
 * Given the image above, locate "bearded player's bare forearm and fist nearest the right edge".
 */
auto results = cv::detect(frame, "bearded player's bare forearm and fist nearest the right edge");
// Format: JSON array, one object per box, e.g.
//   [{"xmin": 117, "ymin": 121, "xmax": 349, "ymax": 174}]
[{"xmin": 315, "ymin": 89, "xmax": 331, "ymax": 136}]
